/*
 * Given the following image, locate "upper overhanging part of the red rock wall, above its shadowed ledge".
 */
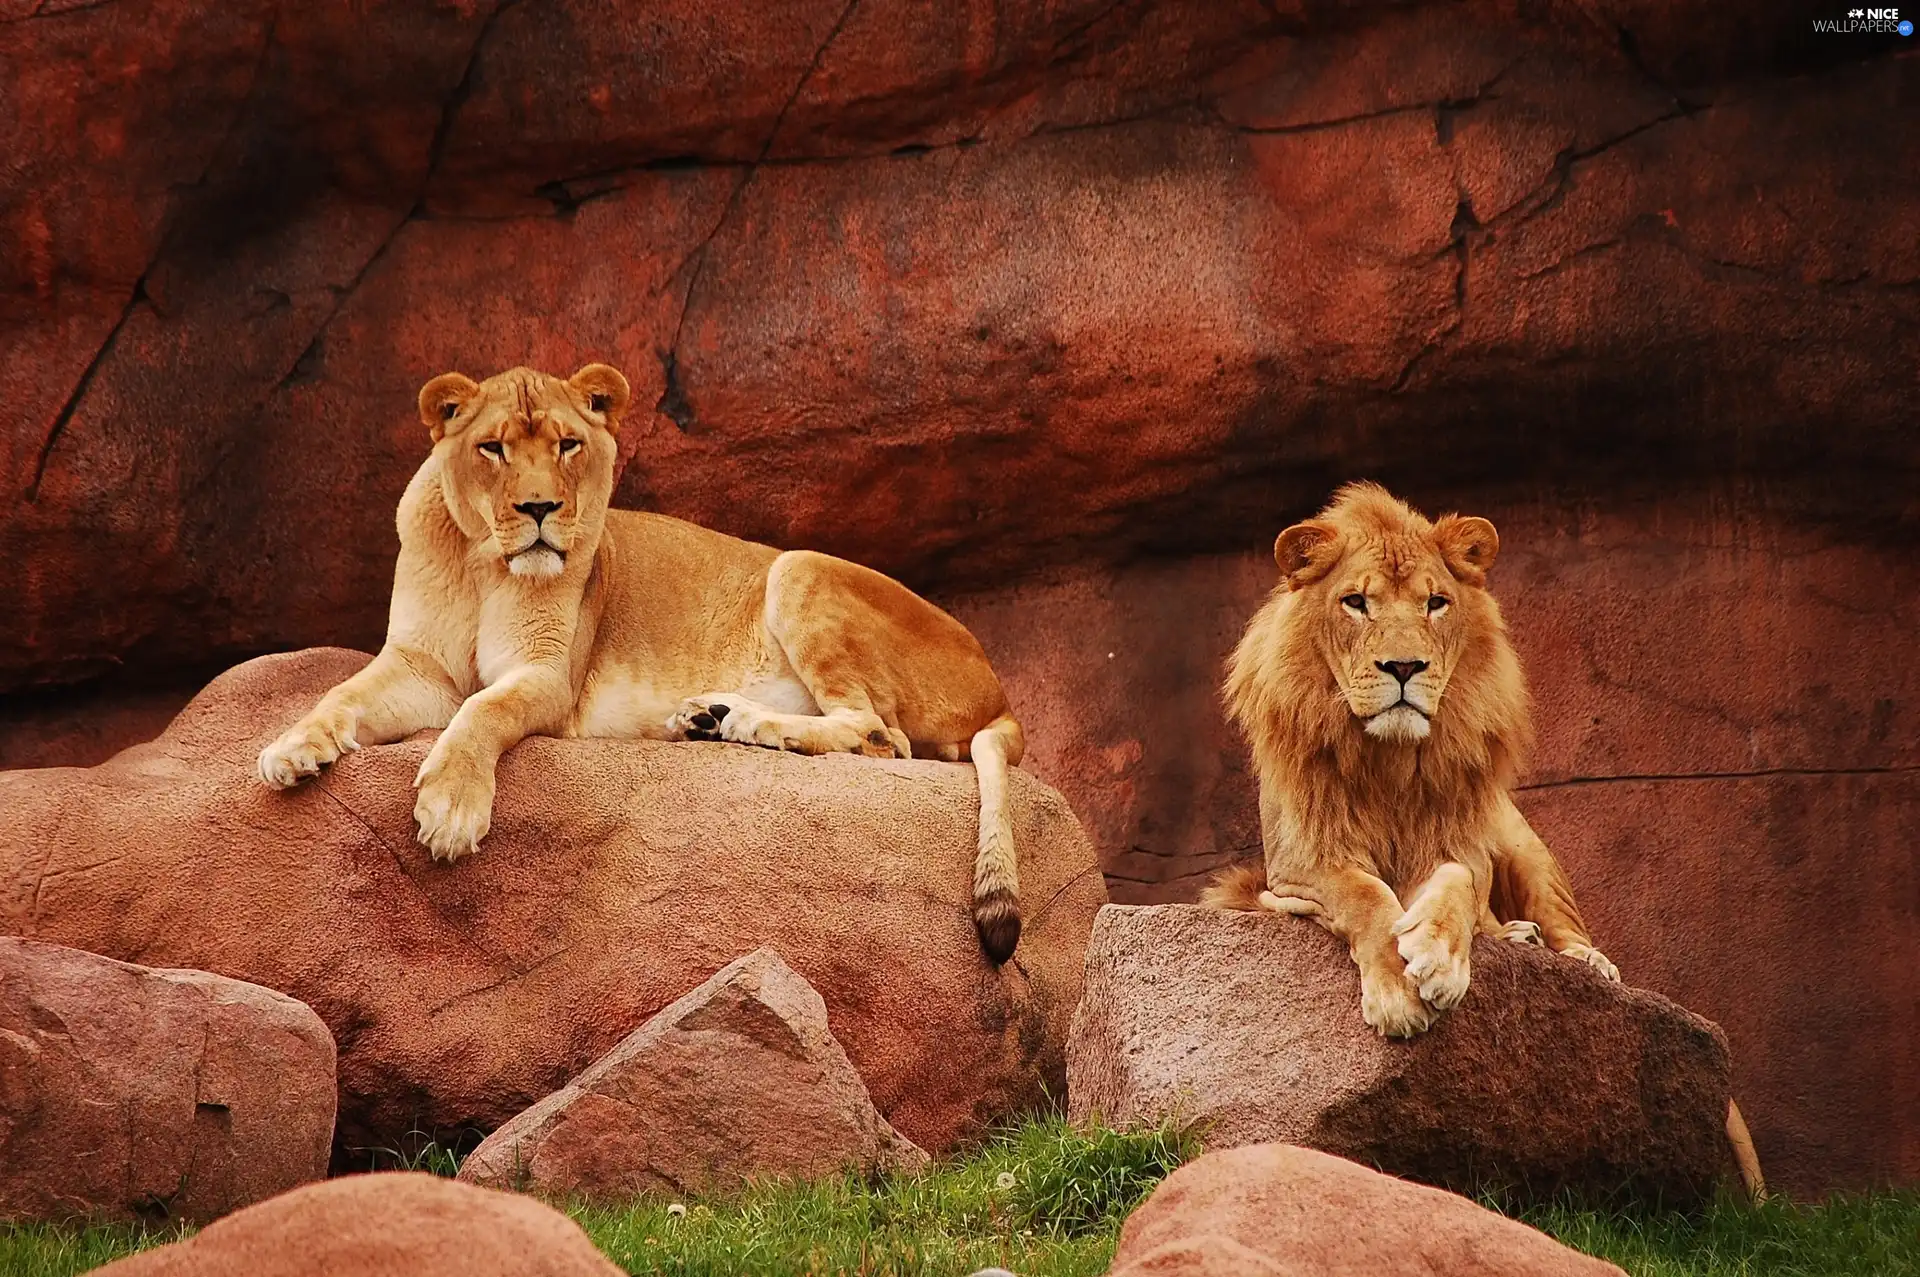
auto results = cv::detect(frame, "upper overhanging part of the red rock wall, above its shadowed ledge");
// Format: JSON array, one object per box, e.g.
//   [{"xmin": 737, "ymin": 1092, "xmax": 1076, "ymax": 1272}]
[{"xmin": 0, "ymin": 0, "xmax": 1920, "ymax": 687}]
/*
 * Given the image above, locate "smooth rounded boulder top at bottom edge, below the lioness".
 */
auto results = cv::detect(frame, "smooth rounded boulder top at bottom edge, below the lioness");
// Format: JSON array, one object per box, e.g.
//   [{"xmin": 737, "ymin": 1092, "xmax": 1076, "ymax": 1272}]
[{"xmin": 94, "ymin": 1171, "xmax": 620, "ymax": 1277}]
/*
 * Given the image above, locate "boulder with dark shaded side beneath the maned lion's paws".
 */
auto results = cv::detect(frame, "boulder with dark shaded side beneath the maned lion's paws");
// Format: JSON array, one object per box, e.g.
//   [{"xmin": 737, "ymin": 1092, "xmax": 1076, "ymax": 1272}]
[{"xmin": 1068, "ymin": 904, "xmax": 1730, "ymax": 1202}]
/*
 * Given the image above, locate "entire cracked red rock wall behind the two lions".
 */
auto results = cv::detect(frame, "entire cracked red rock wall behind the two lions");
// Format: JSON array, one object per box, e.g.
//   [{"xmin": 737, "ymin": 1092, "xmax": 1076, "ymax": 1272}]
[{"xmin": 0, "ymin": 0, "xmax": 1920, "ymax": 1189}]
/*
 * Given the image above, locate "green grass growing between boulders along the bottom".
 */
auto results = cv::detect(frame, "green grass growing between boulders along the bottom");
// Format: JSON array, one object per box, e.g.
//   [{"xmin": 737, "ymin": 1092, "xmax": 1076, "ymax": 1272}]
[{"xmin": 0, "ymin": 1120, "xmax": 1920, "ymax": 1277}]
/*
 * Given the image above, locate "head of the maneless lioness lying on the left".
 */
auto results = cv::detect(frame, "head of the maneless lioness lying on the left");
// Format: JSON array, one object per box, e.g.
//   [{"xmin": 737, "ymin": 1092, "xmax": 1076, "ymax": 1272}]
[{"xmin": 420, "ymin": 363, "xmax": 630, "ymax": 576}]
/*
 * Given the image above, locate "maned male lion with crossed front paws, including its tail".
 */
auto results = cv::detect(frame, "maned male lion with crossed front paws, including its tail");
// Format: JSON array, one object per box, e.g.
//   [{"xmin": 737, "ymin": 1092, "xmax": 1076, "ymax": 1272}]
[{"xmin": 1202, "ymin": 484, "xmax": 1761, "ymax": 1193}]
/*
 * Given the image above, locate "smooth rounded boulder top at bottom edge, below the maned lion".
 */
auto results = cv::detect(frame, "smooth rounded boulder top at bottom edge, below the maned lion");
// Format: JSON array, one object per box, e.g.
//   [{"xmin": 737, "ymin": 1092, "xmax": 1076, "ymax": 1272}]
[{"xmin": 1112, "ymin": 1144, "xmax": 1624, "ymax": 1277}]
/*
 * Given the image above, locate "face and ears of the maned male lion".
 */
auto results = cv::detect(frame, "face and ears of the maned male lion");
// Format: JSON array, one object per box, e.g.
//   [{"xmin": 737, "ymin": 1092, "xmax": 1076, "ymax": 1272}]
[{"xmin": 1275, "ymin": 517, "xmax": 1500, "ymax": 745}]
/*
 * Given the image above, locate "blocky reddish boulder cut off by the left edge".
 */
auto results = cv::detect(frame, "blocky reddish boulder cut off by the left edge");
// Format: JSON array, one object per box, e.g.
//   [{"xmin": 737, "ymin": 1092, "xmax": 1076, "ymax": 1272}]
[{"xmin": 0, "ymin": 935, "xmax": 334, "ymax": 1223}]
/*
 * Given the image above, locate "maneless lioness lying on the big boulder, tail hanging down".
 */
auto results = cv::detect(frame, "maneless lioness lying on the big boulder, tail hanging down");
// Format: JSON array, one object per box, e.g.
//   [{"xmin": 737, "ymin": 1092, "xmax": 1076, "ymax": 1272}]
[{"xmin": 259, "ymin": 363, "xmax": 1025, "ymax": 964}]
